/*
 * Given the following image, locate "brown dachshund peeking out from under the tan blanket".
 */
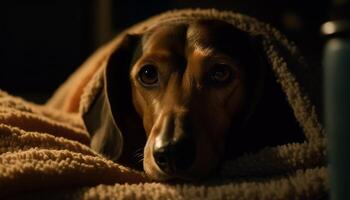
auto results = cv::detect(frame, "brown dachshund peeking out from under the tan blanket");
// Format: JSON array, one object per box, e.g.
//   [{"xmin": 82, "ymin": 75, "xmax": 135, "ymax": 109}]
[{"xmin": 86, "ymin": 20, "xmax": 302, "ymax": 181}]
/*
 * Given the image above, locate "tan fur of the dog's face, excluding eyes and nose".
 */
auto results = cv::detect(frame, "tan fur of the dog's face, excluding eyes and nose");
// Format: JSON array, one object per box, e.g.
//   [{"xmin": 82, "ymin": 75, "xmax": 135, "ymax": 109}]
[{"xmin": 130, "ymin": 22, "xmax": 246, "ymax": 180}]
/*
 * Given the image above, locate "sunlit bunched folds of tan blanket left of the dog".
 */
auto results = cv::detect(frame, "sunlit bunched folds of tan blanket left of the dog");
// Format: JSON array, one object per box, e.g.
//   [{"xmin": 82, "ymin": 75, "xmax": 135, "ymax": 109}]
[{"xmin": 0, "ymin": 91, "xmax": 147, "ymax": 198}]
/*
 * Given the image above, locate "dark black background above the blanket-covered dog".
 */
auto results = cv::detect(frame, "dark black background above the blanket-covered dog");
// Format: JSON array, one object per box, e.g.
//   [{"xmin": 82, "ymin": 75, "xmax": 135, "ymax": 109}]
[{"xmin": 0, "ymin": 0, "xmax": 330, "ymax": 103}]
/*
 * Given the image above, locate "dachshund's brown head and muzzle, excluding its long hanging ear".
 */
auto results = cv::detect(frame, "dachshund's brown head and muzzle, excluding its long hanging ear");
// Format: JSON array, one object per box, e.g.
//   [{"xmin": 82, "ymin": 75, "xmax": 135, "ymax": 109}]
[{"xmin": 130, "ymin": 21, "xmax": 262, "ymax": 180}]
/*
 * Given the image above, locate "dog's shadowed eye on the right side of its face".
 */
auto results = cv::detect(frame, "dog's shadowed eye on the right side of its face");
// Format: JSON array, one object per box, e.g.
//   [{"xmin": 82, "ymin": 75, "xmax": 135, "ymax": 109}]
[{"xmin": 209, "ymin": 64, "xmax": 232, "ymax": 84}]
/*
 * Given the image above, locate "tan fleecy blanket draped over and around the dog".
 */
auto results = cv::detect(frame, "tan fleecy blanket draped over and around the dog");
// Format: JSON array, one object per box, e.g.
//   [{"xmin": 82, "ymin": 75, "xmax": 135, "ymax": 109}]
[{"xmin": 0, "ymin": 10, "xmax": 329, "ymax": 199}]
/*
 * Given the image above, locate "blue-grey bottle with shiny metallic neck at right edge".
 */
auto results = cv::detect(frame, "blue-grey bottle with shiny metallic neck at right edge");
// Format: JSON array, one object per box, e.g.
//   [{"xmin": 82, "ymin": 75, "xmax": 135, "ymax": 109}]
[{"xmin": 321, "ymin": 0, "xmax": 350, "ymax": 200}]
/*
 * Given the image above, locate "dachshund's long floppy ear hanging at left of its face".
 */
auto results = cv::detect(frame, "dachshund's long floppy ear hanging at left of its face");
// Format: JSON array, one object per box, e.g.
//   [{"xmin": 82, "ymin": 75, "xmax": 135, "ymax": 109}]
[{"xmin": 84, "ymin": 35, "xmax": 146, "ymax": 167}]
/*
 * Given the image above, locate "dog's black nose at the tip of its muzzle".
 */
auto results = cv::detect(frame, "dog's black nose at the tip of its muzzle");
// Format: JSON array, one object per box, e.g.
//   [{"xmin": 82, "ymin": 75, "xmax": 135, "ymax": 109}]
[{"xmin": 153, "ymin": 138, "xmax": 196, "ymax": 173}]
